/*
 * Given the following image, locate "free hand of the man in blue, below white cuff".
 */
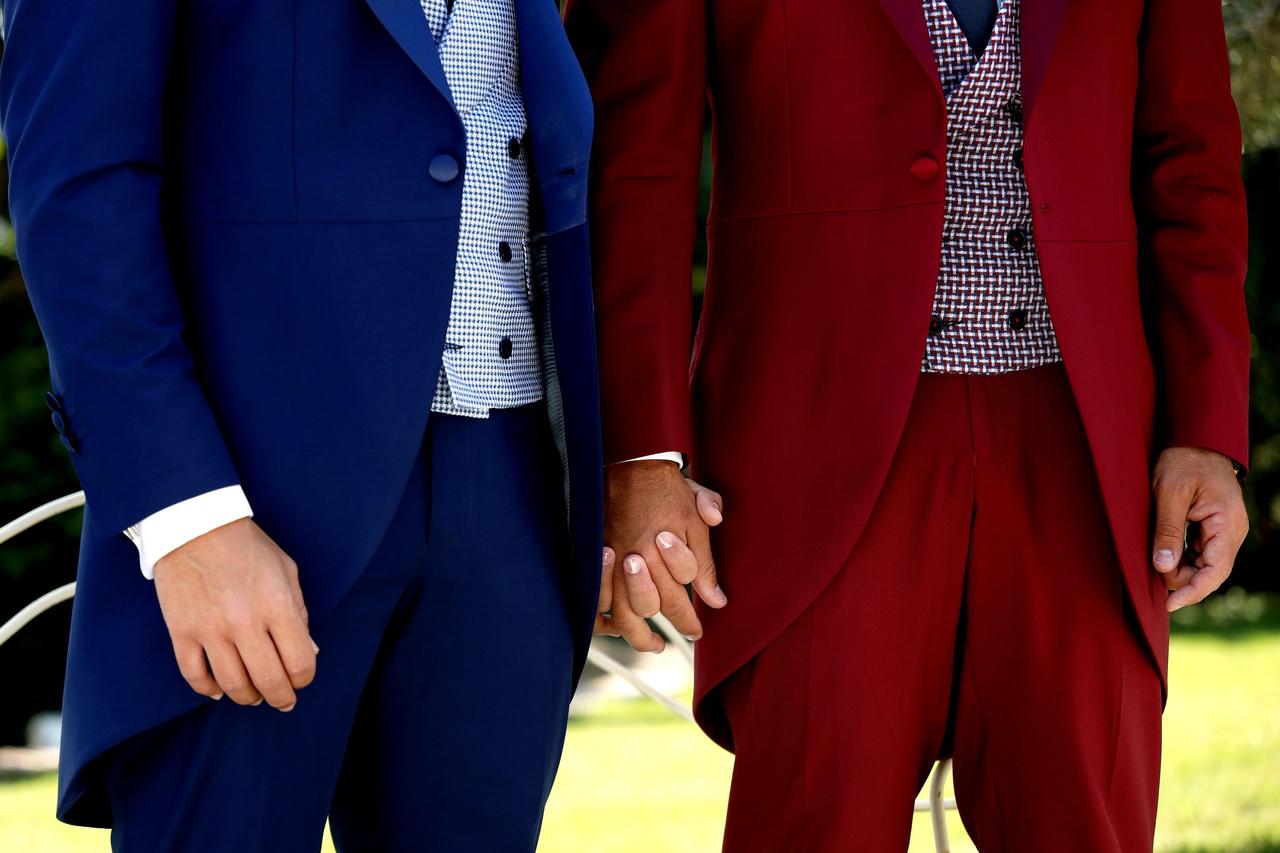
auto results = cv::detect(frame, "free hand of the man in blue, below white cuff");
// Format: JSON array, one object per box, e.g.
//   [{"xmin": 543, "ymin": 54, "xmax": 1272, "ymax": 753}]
[{"xmin": 155, "ymin": 519, "xmax": 320, "ymax": 711}]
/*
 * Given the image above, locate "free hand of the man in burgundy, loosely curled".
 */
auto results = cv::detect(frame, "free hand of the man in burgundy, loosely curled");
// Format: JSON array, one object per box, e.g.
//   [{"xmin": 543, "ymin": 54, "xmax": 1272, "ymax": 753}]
[{"xmin": 1152, "ymin": 447, "xmax": 1249, "ymax": 612}]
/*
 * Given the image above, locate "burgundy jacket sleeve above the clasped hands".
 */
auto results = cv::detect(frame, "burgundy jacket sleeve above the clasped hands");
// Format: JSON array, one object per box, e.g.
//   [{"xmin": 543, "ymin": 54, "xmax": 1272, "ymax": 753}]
[{"xmin": 566, "ymin": 0, "xmax": 708, "ymax": 462}]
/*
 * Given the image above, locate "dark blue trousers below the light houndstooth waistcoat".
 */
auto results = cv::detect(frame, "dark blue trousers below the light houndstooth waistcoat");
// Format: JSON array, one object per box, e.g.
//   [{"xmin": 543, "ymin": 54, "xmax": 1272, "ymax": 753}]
[{"xmin": 108, "ymin": 405, "xmax": 573, "ymax": 853}]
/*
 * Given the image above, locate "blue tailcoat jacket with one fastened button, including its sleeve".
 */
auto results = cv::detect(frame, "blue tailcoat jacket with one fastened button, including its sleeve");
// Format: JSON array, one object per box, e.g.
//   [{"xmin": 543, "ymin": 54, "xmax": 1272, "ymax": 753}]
[{"xmin": 0, "ymin": 0, "xmax": 600, "ymax": 824}]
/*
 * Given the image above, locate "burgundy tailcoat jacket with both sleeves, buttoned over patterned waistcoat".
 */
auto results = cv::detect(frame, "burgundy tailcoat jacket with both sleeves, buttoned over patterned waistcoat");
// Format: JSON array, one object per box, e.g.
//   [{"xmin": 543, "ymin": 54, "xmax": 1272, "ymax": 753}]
[{"xmin": 567, "ymin": 0, "xmax": 1249, "ymax": 745}]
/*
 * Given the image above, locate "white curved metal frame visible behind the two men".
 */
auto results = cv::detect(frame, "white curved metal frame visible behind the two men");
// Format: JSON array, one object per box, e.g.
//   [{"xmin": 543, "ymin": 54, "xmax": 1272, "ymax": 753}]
[{"xmin": 0, "ymin": 492, "xmax": 956, "ymax": 853}]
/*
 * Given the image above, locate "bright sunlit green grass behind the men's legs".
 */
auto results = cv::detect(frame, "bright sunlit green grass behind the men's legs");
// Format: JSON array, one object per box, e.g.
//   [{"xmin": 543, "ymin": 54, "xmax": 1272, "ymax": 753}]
[{"xmin": 0, "ymin": 594, "xmax": 1280, "ymax": 853}]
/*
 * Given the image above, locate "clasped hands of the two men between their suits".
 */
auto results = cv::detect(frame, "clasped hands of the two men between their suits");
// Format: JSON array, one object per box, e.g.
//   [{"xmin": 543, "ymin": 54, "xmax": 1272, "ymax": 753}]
[{"xmin": 596, "ymin": 461, "xmax": 728, "ymax": 652}]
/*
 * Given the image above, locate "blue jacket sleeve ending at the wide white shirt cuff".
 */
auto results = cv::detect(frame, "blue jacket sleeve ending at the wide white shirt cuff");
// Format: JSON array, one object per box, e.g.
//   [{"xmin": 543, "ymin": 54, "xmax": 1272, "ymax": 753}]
[{"xmin": 0, "ymin": 0, "xmax": 238, "ymax": 535}]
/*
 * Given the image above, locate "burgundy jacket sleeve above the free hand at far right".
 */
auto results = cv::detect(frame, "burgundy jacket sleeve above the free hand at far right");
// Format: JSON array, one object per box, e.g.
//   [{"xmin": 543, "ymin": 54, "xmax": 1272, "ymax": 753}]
[{"xmin": 1134, "ymin": 0, "xmax": 1249, "ymax": 464}]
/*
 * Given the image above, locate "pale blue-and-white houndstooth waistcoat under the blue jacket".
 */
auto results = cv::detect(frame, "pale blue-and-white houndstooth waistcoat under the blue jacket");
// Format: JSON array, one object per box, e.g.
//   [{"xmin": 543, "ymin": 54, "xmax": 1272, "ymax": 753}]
[{"xmin": 421, "ymin": 0, "xmax": 543, "ymax": 418}]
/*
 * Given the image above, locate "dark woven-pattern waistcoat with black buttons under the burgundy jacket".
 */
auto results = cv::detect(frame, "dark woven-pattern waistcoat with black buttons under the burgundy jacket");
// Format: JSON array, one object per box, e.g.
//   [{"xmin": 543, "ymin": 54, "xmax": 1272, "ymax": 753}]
[{"xmin": 922, "ymin": 0, "xmax": 1062, "ymax": 374}]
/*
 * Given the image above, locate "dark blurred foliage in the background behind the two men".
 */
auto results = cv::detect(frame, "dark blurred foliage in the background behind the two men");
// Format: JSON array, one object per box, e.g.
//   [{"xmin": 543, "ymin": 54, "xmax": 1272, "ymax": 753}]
[{"xmin": 0, "ymin": 0, "xmax": 1280, "ymax": 743}]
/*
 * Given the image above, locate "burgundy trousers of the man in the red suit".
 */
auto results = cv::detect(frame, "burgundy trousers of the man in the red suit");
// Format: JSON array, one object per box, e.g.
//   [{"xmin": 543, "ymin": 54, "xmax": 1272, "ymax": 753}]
[{"xmin": 722, "ymin": 366, "xmax": 1162, "ymax": 853}]
